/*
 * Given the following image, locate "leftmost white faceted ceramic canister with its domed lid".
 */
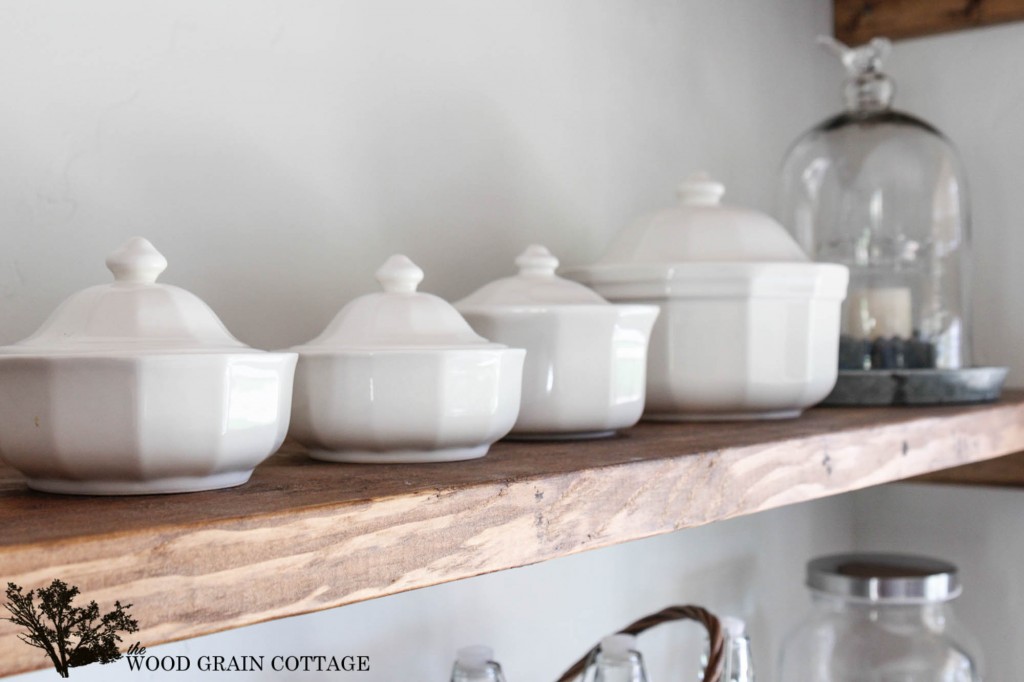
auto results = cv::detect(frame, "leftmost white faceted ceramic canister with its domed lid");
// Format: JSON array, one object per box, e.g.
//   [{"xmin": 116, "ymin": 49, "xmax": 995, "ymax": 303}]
[{"xmin": 0, "ymin": 238, "xmax": 296, "ymax": 495}]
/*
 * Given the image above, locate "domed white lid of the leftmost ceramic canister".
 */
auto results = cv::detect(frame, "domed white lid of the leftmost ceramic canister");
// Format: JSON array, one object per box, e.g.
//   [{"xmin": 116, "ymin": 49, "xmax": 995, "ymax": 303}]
[{"xmin": 0, "ymin": 237, "xmax": 256, "ymax": 355}]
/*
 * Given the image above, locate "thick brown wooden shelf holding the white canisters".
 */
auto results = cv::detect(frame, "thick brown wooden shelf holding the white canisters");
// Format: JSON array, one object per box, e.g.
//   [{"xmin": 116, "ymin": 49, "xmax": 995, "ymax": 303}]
[{"xmin": 0, "ymin": 392, "xmax": 1024, "ymax": 676}]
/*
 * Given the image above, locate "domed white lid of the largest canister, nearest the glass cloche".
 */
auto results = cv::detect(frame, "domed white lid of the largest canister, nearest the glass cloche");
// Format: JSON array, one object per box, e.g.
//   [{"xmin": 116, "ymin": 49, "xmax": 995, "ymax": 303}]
[{"xmin": 595, "ymin": 173, "xmax": 810, "ymax": 265}]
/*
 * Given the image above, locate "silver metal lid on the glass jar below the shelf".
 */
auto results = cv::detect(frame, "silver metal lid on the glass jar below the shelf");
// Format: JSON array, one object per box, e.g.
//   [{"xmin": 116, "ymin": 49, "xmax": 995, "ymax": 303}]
[{"xmin": 807, "ymin": 553, "xmax": 961, "ymax": 604}]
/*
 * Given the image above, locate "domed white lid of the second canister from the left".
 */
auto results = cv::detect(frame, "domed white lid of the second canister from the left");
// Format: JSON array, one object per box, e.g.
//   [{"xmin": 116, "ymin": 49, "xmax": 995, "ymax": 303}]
[{"xmin": 296, "ymin": 255, "xmax": 505, "ymax": 352}]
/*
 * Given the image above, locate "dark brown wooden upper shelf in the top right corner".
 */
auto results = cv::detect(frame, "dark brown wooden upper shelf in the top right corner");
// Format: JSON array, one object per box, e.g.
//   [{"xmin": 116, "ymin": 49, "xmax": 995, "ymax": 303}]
[{"xmin": 833, "ymin": 0, "xmax": 1024, "ymax": 45}]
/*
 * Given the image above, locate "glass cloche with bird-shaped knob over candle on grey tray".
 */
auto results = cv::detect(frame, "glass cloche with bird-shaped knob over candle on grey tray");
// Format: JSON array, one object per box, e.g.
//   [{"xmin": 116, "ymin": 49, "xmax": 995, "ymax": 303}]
[{"xmin": 780, "ymin": 37, "xmax": 1005, "ymax": 404}]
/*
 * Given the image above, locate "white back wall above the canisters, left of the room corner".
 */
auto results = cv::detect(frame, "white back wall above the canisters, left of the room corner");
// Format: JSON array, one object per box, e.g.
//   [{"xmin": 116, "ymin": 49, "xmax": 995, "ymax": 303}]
[{"xmin": 0, "ymin": 0, "xmax": 829, "ymax": 347}]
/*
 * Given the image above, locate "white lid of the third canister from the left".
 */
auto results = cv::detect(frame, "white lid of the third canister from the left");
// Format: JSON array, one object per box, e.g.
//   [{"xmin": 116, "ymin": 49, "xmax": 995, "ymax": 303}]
[{"xmin": 456, "ymin": 244, "xmax": 611, "ymax": 310}]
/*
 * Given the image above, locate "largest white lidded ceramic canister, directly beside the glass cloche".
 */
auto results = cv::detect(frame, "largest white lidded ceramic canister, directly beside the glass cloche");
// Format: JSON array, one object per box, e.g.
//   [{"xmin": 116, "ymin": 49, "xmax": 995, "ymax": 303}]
[{"xmin": 567, "ymin": 174, "xmax": 849, "ymax": 420}]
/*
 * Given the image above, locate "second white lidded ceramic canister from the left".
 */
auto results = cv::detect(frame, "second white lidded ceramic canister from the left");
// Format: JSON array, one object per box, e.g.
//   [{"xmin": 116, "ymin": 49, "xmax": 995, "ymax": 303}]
[{"xmin": 291, "ymin": 255, "xmax": 525, "ymax": 463}]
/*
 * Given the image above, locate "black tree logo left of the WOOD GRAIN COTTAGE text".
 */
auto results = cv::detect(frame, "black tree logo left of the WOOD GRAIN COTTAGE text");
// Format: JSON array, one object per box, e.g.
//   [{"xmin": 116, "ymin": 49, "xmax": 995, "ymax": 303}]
[{"xmin": 4, "ymin": 580, "xmax": 138, "ymax": 677}]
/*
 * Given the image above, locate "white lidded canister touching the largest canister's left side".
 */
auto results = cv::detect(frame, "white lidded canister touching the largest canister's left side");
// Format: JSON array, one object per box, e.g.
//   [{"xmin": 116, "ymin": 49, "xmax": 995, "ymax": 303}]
[{"xmin": 456, "ymin": 246, "xmax": 658, "ymax": 438}]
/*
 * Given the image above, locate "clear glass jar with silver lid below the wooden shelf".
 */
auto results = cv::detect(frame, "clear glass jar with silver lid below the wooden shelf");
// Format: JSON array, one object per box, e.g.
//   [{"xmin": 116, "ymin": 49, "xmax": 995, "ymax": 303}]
[{"xmin": 778, "ymin": 554, "xmax": 981, "ymax": 682}]
